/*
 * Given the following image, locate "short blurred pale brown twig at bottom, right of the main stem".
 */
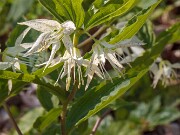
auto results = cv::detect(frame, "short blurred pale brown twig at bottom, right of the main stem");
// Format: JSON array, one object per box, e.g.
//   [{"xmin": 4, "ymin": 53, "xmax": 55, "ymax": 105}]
[{"xmin": 90, "ymin": 110, "xmax": 111, "ymax": 135}]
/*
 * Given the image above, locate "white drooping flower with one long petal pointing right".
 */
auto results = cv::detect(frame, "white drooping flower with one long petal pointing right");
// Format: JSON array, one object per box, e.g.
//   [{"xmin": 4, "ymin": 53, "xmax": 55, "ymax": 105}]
[{"xmin": 85, "ymin": 37, "xmax": 144, "ymax": 89}]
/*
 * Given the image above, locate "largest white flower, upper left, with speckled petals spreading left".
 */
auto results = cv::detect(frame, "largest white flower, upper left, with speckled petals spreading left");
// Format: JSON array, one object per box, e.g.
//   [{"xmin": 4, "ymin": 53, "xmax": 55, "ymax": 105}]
[{"xmin": 15, "ymin": 19, "xmax": 76, "ymax": 70}]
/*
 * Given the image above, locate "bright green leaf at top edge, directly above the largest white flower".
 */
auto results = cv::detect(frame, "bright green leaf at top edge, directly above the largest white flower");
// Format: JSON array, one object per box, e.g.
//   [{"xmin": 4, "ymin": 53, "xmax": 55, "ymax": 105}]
[{"xmin": 39, "ymin": 0, "xmax": 85, "ymax": 28}]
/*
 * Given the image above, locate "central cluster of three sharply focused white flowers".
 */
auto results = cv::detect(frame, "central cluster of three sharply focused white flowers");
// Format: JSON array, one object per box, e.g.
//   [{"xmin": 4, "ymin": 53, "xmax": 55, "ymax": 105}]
[{"xmin": 0, "ymin": 19, "xmax": 144, "ymax": 90}]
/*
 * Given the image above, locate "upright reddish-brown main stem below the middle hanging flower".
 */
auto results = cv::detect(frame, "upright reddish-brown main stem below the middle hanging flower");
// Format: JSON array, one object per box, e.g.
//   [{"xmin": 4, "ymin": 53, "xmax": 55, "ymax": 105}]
[{"xmin": 61, "ymin": 85, "xmax": 77, "ymax": 135}]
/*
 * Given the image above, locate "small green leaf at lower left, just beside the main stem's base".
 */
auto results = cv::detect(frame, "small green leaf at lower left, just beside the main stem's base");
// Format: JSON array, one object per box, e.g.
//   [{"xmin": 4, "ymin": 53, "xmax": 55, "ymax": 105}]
[{"xmin": 34, "ymin": 108, "xmax": 62, "ymax": 131}]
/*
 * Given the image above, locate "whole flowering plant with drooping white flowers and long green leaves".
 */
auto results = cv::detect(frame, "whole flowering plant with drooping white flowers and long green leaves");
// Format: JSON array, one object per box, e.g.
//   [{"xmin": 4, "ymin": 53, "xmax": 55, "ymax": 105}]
[{"xmin": 0, "ymin": 0, "xmax": 180, "ymax": 135}]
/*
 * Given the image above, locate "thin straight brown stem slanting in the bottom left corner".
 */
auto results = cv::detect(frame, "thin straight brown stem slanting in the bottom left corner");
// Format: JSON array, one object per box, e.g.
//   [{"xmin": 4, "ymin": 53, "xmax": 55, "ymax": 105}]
[{"xmin": 3, "ymin": 102, "xmax": 23, "ymax": 135}]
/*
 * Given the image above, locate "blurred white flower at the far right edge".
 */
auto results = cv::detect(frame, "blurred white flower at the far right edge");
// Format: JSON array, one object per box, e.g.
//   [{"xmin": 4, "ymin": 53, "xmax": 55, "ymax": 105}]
[{"xmin": 150, "ymin": 57, "xmax": 180, "ymax": 88}]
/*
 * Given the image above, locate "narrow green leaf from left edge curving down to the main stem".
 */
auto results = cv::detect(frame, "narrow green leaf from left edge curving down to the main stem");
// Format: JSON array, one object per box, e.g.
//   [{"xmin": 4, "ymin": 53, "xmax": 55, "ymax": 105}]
[{"xmin": 0, "ymin": 70, "xmax": 67, "ymax": 101}]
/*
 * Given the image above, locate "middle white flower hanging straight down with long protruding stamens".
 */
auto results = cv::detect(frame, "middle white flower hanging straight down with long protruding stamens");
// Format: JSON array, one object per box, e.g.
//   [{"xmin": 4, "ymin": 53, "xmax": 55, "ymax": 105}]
[{"xmin": 49, "ymin": 47, "xmax": 87, "ymax": 90}]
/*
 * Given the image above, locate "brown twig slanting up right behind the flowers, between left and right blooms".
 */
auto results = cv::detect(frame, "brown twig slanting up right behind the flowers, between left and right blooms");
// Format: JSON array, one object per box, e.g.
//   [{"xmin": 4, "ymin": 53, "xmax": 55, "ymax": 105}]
[{"xmin": 77, "ymin": 25, "xmax": 107, "ymax": 48}]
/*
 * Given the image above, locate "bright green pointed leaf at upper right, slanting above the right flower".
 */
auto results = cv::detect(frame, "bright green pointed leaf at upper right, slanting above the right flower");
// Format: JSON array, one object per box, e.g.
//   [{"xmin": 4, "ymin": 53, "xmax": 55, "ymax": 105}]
[{"xmin": 110, "ymin": 0, "xmax": 161, "ymax": 44}]
